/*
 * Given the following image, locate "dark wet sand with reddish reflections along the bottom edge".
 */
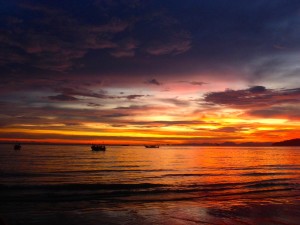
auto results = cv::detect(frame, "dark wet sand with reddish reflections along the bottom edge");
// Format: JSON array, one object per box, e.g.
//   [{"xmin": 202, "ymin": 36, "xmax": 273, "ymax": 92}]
[{"xmin": 0, "ymin": 200, "xmax": 300, "ymax": 225}]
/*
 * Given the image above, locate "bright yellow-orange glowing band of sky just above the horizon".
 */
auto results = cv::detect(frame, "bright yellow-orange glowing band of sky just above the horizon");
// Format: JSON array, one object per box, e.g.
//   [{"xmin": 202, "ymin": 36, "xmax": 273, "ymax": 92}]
[{"xmin": 0, "ymin": 100, "xmax": 300, "ymax": 143}]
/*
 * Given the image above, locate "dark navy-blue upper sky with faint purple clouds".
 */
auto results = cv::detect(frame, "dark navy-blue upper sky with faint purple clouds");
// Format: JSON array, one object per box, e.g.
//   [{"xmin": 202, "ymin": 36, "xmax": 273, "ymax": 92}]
[{"xmin": 0, "ymin": 0, "xmax": 300, "ymax": 79}]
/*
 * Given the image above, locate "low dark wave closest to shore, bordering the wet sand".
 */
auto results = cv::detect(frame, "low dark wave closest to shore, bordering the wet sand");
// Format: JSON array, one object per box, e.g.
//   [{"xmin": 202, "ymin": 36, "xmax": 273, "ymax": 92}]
[{"xmin": 0, "ymin": 187, "xmax": 300, "ymax": 203}]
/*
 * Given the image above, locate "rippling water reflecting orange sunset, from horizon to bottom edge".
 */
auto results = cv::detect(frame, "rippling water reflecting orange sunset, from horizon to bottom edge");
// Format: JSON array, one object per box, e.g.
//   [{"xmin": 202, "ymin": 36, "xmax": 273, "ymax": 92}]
[{"xmin": 0, "ymin": 145, "xmax": 300, "ymax": 225}]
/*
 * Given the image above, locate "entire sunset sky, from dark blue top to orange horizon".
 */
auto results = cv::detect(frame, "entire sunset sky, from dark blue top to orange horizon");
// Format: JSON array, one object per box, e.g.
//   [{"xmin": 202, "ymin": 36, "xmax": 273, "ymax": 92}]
[{"xmin": 0, "ymin": 0, "xmax": 300, "ymax": 144}]
